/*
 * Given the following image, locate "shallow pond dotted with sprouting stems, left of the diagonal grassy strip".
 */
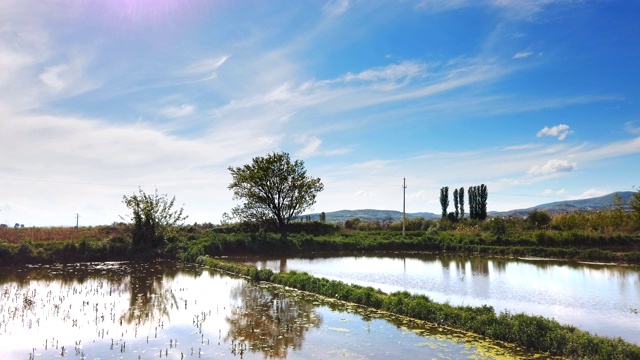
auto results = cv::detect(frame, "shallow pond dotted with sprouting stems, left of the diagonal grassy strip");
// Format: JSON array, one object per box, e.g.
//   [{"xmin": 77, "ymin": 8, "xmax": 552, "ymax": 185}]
[{"xmin": 0, "ymin": 262, "xmax": 528, "ymax": 360}]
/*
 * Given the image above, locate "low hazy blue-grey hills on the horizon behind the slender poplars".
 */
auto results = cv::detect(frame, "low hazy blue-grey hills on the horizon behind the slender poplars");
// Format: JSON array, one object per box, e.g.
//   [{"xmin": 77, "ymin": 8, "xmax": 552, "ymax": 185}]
[{"xmin": 301, "ymin": 191, "xmax": 633, "ymax": 222}]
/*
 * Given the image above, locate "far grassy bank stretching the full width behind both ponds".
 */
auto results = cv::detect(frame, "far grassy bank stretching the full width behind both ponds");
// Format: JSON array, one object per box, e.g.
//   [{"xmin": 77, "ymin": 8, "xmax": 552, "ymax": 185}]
[{"xmin": 0, "ymin": 224, "xmax": 640, "ymax": 265}]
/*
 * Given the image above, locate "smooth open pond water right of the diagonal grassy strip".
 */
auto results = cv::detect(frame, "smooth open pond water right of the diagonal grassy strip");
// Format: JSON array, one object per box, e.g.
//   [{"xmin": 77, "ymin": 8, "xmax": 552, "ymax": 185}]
[{"xmin": 235, "ymin": 254, "xmax": 640, "ymax": 345}]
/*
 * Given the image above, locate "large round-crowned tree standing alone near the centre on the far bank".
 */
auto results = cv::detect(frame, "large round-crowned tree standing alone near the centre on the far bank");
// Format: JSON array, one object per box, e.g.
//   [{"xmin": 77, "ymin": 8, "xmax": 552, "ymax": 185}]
[{"xmin": 229, "ymin": 152, "xmax": 324, "ymax": 233}]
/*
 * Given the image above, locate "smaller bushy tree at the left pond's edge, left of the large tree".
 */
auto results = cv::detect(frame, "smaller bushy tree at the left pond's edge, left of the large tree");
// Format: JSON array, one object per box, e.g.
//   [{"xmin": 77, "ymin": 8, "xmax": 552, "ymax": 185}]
[{"xmin": 120, "ymin": 188, "xmax": 187, "ymax": 248}]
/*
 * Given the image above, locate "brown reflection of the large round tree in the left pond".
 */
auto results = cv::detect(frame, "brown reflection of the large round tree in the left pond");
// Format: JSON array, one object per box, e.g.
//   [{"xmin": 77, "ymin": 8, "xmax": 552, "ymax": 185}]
[{"xmin": 225, "ymin": 282, "xmax": 322, "ymax": 358}]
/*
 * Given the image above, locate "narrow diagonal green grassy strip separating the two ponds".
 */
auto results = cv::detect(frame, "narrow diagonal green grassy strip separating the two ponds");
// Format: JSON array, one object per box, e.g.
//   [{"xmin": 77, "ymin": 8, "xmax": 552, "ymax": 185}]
[{"xmin": 197, "ymin": 257, "xmax": 640, "ymax": 359}]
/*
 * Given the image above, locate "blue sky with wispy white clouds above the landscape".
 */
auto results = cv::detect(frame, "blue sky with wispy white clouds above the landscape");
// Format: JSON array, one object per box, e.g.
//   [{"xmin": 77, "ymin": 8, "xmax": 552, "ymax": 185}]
[{"xmin": 0, "ymin": 0, "xmax": 640, "ymax": 226}]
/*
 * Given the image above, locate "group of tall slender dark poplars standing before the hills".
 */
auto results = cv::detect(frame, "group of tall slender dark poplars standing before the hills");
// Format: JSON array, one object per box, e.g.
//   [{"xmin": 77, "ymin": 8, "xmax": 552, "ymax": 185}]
[{"xmin": 440, "ymin": 184, "xmax": 489, "ymax": 221}]
